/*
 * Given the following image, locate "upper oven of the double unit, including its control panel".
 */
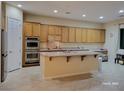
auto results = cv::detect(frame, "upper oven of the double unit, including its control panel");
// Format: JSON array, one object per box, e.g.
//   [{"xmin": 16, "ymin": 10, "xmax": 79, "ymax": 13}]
[{"xmin": 25, "ymin": 37, "xmax": 40, "ymax": 50}]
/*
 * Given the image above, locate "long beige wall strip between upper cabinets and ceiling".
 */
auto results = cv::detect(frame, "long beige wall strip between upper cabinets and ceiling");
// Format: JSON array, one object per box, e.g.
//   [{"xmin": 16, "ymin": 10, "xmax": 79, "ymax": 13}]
[{"xmin": 24, "ymin": 14, "xmax": 103, "ymax": 28}]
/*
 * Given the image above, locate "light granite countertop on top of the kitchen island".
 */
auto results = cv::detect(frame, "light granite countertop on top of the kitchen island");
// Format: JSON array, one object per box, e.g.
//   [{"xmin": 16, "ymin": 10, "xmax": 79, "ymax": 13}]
[{"xmin": 40, "ymin": 51, "xmax": 100, "ymax": 57}]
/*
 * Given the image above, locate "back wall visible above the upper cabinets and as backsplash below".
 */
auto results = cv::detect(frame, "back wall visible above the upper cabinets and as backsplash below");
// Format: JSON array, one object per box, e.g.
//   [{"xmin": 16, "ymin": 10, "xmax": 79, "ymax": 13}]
[{"xmin": 24, "ymin": 14, "xmax": 103, "ymax": 48}]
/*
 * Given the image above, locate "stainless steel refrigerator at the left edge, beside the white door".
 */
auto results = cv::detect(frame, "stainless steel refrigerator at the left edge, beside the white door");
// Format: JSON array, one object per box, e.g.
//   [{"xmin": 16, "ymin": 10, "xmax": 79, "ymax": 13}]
[{"xmin": 1, "ymin": 29, "xmax": 8, "ymax": 82}]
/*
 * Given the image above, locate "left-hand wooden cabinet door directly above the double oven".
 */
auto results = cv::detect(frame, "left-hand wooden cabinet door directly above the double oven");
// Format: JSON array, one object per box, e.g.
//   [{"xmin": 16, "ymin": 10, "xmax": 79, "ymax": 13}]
[{"xmin": 24, "ymin": 22, "xmax": 33, "ymax": 36}]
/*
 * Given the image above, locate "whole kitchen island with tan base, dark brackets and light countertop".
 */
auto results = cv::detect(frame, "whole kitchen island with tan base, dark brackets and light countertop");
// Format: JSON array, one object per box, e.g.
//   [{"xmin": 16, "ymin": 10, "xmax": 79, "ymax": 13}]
[{"xmin": 40, "ymin": 51, "xmax": 99, "ymax": 79}]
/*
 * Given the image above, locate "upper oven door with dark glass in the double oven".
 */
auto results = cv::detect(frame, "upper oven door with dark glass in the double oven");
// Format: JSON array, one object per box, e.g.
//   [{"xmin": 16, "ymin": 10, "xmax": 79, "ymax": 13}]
[{"xmin": 26, "ymin": 40, "xmax": 39, "ymax": 49}]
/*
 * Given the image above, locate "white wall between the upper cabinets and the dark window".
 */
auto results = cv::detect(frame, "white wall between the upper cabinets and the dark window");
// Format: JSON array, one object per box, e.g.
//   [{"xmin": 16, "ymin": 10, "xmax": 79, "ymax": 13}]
[{"xmin": 104, "ymin": 18, "xmax": 124, "ymax": 62}]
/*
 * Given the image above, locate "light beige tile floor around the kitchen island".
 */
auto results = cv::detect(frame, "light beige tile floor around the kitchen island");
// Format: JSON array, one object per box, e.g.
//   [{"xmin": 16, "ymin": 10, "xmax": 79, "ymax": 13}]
[{"xmin": 0, "ymin": 62, "xmax": 124, "ymax": 91}]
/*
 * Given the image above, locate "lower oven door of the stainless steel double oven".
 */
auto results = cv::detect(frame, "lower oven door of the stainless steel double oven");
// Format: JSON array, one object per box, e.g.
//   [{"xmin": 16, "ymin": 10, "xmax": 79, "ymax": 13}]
[{"xmin": 25, "ymin": 52, "xmax": 40, "ymax": 64}]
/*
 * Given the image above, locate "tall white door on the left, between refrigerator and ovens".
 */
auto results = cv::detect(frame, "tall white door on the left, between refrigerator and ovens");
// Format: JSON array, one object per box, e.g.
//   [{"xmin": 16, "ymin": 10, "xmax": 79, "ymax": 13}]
[{"xmin": 7, "ymin": 18, "xmax": 22, "ymax": 72}]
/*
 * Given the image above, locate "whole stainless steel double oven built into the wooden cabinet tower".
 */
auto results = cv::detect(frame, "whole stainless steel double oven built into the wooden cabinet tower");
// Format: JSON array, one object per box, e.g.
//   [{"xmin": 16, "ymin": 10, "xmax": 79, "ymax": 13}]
[{"xmin": 25, "ymin": 37, "xmax": 40, "ymax": 64}]
